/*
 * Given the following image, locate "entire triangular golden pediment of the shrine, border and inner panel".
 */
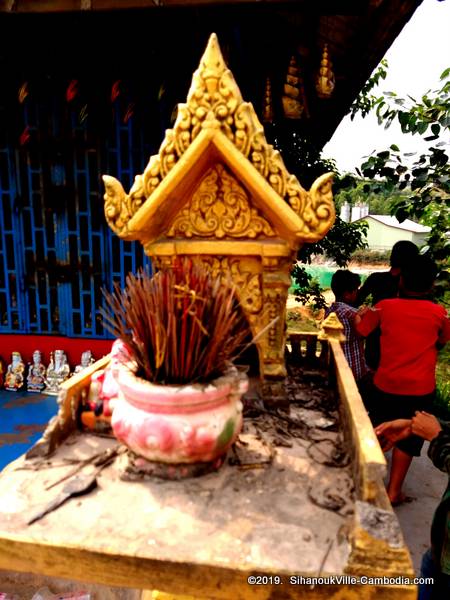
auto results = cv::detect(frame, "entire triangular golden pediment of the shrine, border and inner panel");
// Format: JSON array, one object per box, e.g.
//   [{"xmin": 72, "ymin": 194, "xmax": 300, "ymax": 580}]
[{"xmin": 104, "ymin": 34, "xmax": 334, "ymax": 248}]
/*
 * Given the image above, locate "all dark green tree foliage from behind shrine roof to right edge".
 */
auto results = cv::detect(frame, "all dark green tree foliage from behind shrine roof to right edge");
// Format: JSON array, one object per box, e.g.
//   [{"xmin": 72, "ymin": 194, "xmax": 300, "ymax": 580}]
[{"xmin": 269, "ymin": 60, "xmax": 450, "ymax": 307}]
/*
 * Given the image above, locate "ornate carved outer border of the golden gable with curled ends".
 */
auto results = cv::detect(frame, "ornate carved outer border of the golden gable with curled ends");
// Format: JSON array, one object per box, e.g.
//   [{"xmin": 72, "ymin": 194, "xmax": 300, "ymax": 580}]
[{"xmin": 104, "ymin": 34, "xmax": 334, "ymax": 243}]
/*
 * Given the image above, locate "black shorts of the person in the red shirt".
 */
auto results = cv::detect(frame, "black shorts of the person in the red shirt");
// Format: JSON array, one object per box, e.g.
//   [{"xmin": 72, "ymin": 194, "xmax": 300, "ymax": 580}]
[{"xmin": 366, "ymin": 385, "xmax": 435, "ymax": 456}]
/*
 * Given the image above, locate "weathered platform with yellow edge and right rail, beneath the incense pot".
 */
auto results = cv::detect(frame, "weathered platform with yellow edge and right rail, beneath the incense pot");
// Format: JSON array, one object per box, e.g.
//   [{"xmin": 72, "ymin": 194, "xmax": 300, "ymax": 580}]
[{"xmin": 0, "ymin": 345, "xmax": 416, "ymax": 600}]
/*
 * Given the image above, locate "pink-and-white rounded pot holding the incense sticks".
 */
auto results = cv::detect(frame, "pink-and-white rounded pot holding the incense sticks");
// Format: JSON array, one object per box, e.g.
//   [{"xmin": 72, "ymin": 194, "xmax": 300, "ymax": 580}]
[{"xmin": 111, "ymin": 340, "xmax": 248, "ymax": 464}]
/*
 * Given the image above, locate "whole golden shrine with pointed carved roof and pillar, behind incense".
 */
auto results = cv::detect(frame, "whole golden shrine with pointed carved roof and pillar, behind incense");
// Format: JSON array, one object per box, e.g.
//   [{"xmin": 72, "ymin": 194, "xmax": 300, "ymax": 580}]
[{"xmin": 103, "ymin": 34, "xmax": 335, "ymax": 379}]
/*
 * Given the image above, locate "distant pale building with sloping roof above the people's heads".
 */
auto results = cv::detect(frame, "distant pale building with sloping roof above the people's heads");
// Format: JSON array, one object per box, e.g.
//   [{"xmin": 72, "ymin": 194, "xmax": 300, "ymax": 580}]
[{"xmin": 356, "ymin": 215, "xmax": 431, "ymax": 250}]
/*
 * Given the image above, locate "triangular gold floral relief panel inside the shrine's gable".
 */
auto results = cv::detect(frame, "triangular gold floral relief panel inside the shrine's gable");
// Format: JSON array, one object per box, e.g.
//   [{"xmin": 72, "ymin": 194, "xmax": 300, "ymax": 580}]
[{"xmin": 167, "ymin": 164, "xmax": 275, "ymax": 239}]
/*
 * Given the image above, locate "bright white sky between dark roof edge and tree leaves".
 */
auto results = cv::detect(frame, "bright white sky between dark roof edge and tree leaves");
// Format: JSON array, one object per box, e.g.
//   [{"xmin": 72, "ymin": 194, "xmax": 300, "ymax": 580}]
[{"xmin": 323, "ymin": 0, "xmax": 450, "ymax": 172}]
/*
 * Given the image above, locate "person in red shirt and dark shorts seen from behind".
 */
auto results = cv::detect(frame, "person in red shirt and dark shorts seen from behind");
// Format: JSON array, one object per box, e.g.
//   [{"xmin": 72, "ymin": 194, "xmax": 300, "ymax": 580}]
[{"xmin": 355, "ymin": 256, "xmax": 450, "ymax": 506}]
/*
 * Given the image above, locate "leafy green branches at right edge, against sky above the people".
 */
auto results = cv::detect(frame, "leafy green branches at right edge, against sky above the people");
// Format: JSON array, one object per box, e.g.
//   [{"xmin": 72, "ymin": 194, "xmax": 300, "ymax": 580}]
[{"xmin": 352, "ymin": 68, "xmax": 450, "ymax": 296}]
